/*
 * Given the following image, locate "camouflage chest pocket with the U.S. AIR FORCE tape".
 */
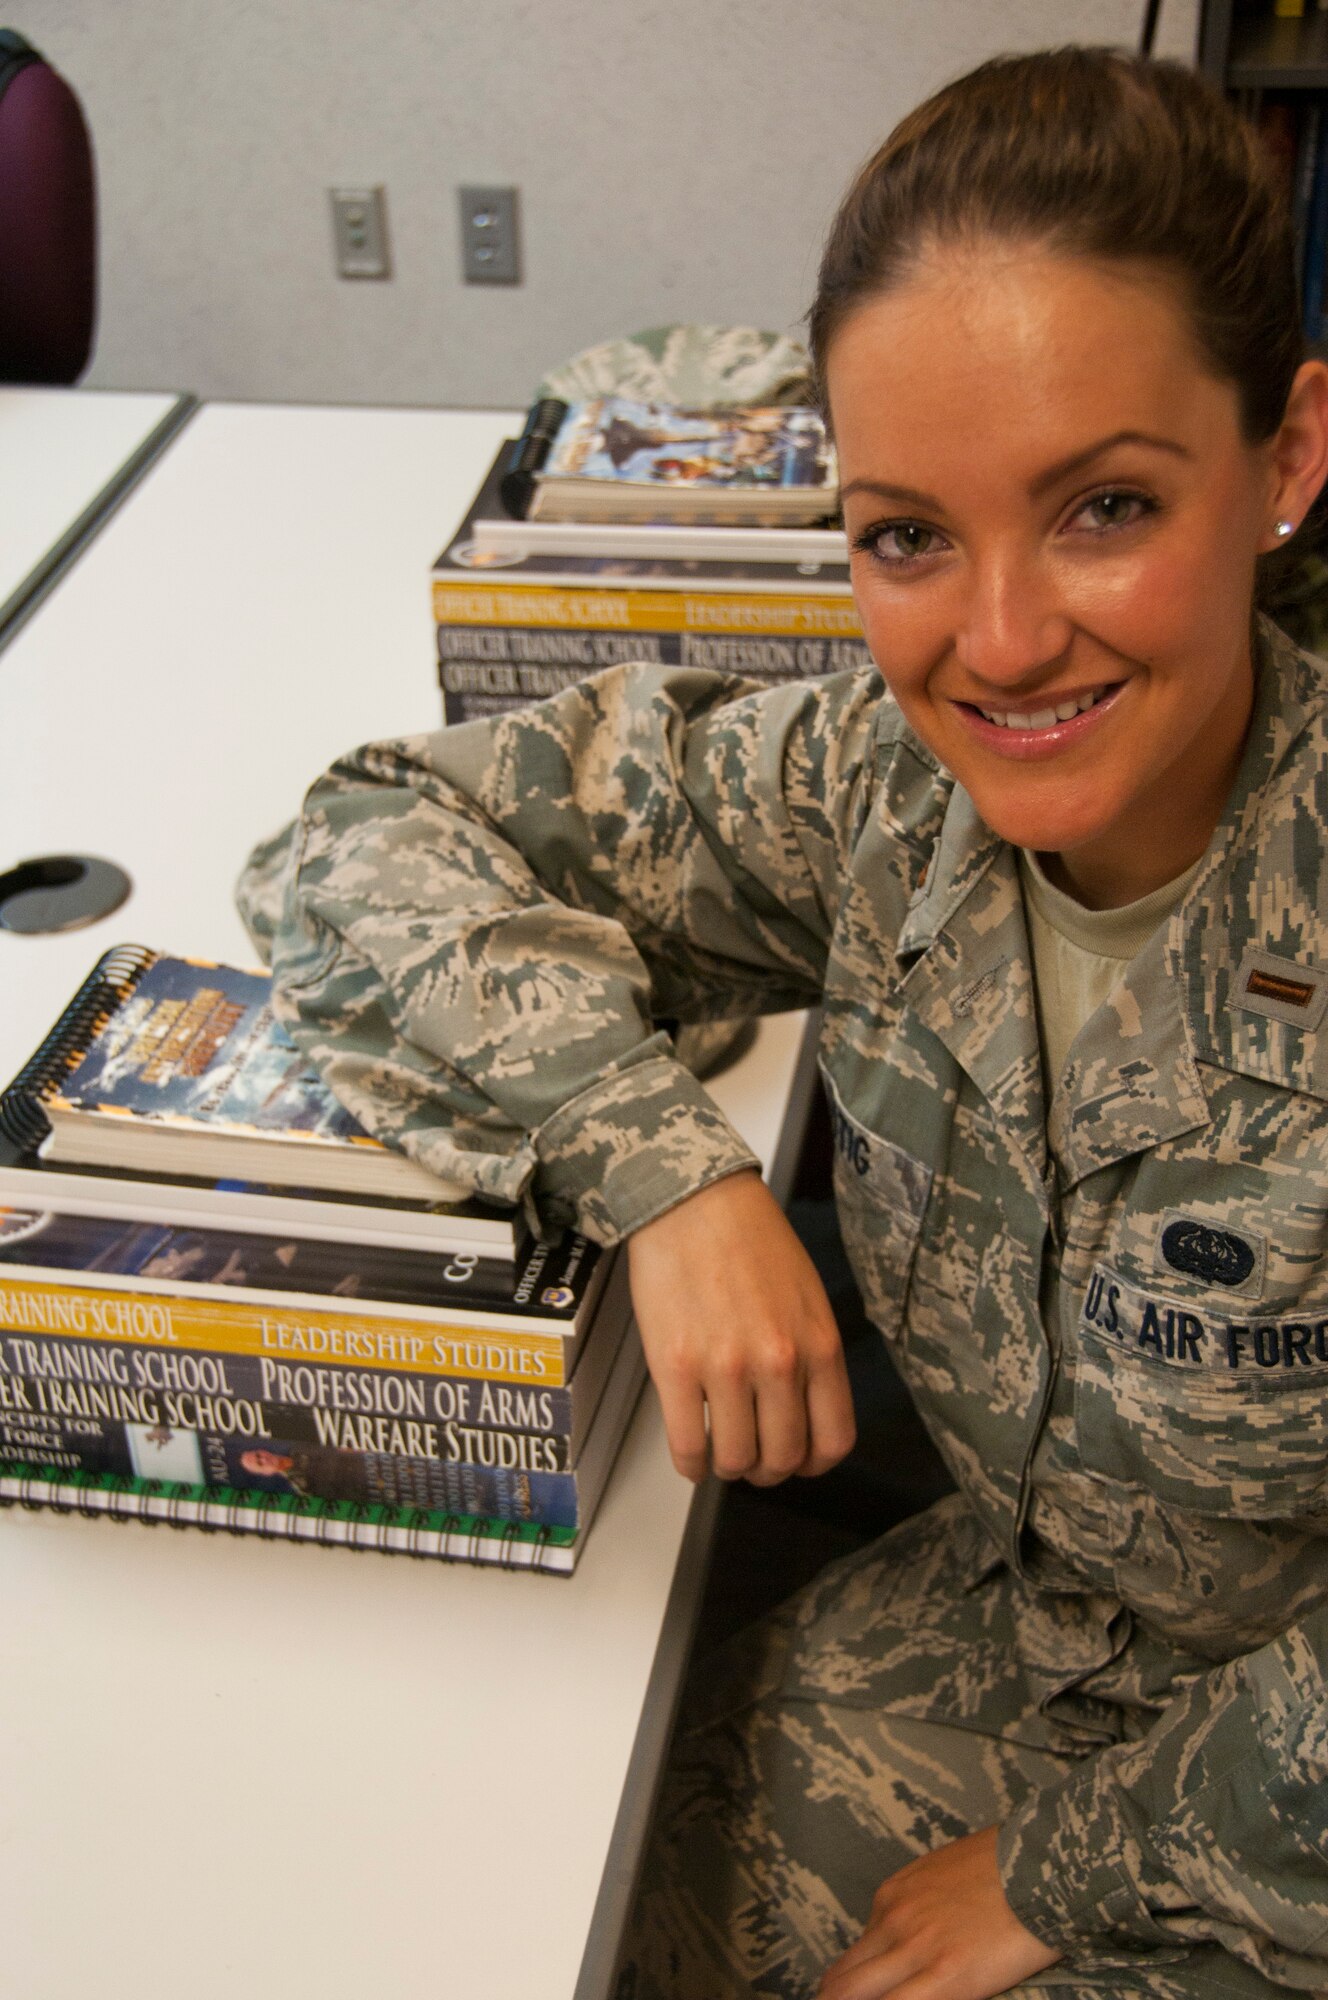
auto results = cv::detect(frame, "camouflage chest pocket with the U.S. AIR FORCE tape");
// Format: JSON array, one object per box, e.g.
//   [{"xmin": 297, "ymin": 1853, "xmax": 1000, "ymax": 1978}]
[{"xmin": 1074, "ymin": 1264, "xmax": 1328, "ymax": 1528}]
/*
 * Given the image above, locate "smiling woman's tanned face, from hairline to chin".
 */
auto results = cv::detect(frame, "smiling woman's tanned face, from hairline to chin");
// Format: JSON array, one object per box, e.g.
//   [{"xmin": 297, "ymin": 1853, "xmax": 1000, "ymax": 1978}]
[{"xmin": 826, "ymin": 244, "xmax": 1278, "ymax": 904}]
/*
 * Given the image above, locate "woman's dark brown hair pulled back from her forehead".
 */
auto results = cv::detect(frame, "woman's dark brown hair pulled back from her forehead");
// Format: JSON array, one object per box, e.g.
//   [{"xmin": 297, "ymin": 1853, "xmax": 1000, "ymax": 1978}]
[{"xmin": 808, "ymin": 48, "xmax": 1304, "ymax": 444}]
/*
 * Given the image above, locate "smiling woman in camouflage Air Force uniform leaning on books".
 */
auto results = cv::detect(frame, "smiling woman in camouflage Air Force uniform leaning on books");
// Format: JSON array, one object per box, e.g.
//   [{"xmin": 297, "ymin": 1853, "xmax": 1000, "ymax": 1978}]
[{"xmin": 244, "ymin": 50, "xmax": 1328, "ymax": 2000}]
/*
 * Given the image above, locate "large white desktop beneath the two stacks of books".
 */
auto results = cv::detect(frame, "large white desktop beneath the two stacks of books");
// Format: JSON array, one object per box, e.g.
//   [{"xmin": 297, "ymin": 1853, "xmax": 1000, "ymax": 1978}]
[{"xmin": 0, "ymin": 406, "xmax": 816, "ymax": 2000}]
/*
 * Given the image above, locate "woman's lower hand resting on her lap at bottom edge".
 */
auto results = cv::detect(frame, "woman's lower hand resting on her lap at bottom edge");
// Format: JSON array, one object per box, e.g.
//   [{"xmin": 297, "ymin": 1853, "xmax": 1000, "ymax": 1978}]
[{"xmin": 820, "ymin": 1826, "xmax": 1060, "ymax": 2000}]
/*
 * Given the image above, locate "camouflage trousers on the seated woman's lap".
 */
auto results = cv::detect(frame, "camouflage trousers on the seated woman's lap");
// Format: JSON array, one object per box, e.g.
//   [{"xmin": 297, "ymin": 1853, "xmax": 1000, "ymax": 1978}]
[{"xmin": 616, "ymin": 1496, "xmax": 1288, "ymax": 2000}]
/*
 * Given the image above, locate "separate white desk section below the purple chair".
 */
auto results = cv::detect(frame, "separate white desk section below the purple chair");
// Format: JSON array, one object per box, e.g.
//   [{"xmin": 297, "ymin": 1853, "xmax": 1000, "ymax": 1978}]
[{"xmin": 0, "ymin": 388, "xmax": 196, "ymax": 644}]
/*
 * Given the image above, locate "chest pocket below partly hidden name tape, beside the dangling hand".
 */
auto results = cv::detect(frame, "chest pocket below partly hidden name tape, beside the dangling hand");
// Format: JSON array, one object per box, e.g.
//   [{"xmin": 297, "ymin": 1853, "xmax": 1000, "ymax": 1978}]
[{"xmin": 822, "ymin": 1068, "xmax": 932, "ymax": 1340}]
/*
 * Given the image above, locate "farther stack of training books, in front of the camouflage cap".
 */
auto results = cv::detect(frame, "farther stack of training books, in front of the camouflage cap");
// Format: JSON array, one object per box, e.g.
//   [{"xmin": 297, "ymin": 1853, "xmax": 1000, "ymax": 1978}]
[{"xmin": 432, "ymin": 396, "xmax": 870, "ymax": 722}]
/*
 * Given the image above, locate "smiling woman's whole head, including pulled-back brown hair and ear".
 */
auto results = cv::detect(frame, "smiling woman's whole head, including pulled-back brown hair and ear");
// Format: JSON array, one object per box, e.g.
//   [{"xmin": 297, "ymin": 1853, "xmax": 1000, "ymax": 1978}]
[{"xmin": 812, "ymin": 50, "xmax": 1328, "ymax": 904}]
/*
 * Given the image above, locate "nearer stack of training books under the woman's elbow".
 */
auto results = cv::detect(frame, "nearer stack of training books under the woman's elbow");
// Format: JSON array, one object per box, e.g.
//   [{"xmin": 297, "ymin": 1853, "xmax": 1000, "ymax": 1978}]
[{"xmin": 0, "ymin": 946, "xmax": 644, "ymax": 1574}]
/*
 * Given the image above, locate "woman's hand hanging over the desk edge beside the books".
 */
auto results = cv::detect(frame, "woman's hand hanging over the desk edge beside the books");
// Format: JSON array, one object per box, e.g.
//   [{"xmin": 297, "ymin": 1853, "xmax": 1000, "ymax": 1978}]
[{"xmin": 628, "ymin": 1172, "xmax": 854, "ymax": 1486}]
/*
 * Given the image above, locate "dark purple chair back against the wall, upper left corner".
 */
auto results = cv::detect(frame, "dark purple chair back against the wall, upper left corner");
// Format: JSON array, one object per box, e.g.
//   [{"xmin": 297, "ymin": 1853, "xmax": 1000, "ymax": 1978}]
[{"xmin": 0, "ymin": 30, "xmax": 96, "ymax": 382}]
